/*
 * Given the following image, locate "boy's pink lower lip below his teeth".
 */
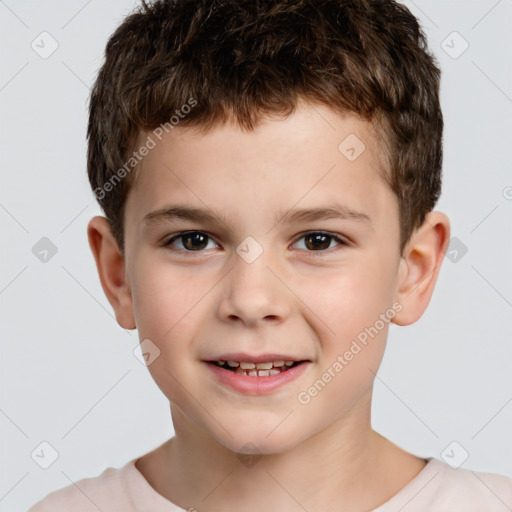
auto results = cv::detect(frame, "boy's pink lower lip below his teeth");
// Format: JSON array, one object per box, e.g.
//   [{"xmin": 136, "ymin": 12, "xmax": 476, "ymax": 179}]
[{"xmin": 205, "ymin": 362, "xmax": 309, "ymax": 395}]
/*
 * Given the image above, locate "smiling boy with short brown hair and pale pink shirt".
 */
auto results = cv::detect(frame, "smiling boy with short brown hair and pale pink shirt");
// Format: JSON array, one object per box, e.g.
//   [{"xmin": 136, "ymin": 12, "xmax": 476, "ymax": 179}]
[{"xmin": 31, "ymin": 0, "xmax": 512, "ymax": 512}]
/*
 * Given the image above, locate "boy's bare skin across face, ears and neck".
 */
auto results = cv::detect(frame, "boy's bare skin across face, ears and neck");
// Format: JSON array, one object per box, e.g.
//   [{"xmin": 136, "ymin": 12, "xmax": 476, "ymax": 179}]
[{"xmin": 88, "ymin": 103, "xmax": 450, "ymax": 512}]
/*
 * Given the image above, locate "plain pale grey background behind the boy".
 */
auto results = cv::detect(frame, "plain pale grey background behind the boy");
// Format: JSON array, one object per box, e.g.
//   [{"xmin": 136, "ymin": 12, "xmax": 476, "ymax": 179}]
[{"xmin": 0, "ymin": 0, "xmax": 512, "ymax": 511}]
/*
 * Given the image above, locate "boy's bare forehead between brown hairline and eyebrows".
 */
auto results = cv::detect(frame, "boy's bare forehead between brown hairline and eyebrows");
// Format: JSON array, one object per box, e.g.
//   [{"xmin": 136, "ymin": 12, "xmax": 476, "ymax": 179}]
[{"xmin": 126, "ymin": 106, "xmax": 394, "ymax": 230}]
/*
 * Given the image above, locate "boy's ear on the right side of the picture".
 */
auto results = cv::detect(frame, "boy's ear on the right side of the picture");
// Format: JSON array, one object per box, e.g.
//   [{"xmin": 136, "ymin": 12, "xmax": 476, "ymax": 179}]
[{"xmin": 391, "ymin": 212, "xmax": 450, "ymax": 325}]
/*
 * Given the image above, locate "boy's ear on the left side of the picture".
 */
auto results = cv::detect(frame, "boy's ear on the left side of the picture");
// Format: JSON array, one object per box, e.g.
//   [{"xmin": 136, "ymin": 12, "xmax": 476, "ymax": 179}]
[{"xmin": 87, "ymin": 217, "xmax": 136, "ymax": 329}]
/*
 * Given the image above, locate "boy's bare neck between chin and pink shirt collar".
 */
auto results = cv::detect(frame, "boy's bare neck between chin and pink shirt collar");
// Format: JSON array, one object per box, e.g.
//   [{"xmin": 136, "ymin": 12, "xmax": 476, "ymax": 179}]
[{"xmin": 139, "ymin": 392, "xmax": 425, "ymax": 512}]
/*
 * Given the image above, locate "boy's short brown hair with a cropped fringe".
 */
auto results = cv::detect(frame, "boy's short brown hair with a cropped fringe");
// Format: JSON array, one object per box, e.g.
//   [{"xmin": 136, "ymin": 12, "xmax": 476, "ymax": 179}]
[{"xmin": 87, "ymin": 0, "xmax": 443, "ymax": 253}]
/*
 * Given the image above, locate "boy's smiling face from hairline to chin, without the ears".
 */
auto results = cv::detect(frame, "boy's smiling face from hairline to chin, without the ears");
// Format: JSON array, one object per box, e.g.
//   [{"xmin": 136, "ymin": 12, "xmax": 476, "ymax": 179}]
[{"xmin": 125, "ymin": 106, "xmax": 400, "ymax": 453}]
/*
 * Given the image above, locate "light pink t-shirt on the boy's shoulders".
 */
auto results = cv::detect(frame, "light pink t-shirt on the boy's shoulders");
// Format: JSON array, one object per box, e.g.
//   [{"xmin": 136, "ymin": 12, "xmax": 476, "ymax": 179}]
[{"xmin": 28, "ymin": 458, "xmax": 512, "ymax": 512}]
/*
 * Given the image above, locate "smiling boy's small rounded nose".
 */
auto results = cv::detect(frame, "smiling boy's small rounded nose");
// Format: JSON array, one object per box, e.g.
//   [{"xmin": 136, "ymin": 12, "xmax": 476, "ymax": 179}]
[{"xmin": 217, "ymin": 251, "xmax": 292, "ymax": 327}]
